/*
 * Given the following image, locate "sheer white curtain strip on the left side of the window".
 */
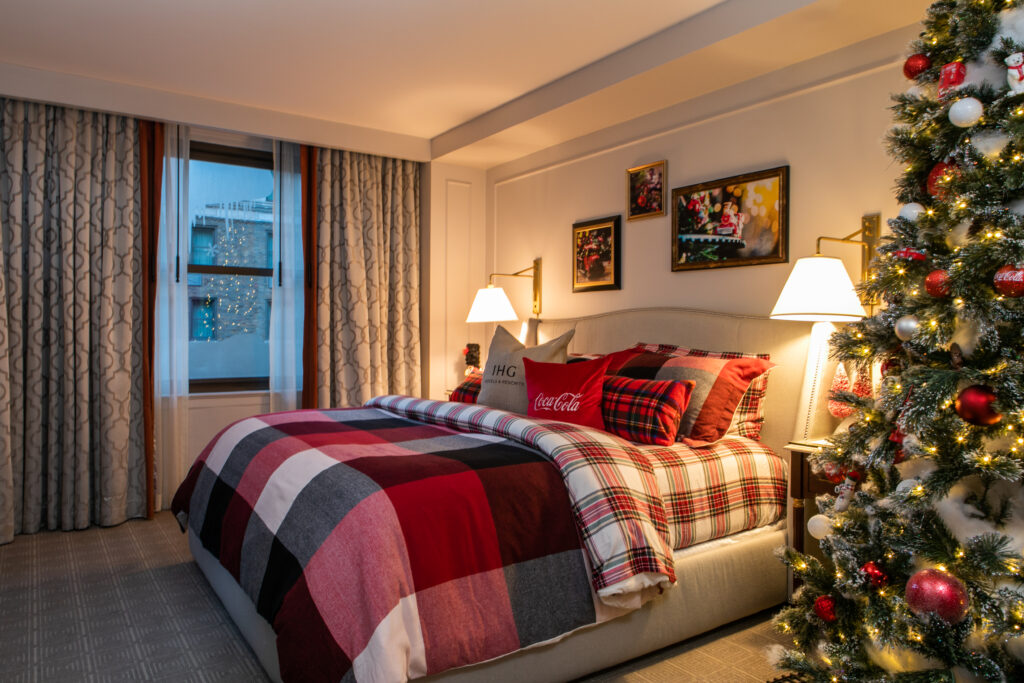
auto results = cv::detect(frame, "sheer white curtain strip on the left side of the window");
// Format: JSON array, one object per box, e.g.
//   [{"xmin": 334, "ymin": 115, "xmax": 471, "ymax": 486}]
[{"xmin": 154, "ymin": 124, "xmax": 191, "ymax": 510}]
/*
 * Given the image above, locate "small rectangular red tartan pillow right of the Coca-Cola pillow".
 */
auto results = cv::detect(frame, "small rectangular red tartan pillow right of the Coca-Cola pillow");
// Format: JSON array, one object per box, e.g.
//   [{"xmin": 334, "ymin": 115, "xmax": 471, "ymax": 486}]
[{"xmin": 601, "ymin": 375, "xmax": 693, "ymax": 445}]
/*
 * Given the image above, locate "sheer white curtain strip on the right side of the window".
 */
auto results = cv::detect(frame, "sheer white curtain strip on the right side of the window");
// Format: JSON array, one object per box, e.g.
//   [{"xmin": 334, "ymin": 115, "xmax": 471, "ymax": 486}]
[{"xmin": 270, "ymin": 142, "xmax": 304, "ymax": 411}]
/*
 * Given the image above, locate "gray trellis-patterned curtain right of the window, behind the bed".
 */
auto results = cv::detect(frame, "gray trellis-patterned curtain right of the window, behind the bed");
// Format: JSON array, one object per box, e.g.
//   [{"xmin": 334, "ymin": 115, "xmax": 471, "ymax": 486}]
[{"xmin": 315, "ymin": 148, "xmax": 420, "ymax": 408}]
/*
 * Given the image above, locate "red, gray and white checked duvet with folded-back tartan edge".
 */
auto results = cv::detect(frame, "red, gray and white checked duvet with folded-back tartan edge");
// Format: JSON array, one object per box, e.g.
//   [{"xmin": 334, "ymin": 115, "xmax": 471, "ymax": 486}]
[{"xmin": 172, "ymin": 403, "xmax": 675, "ymax": 681}]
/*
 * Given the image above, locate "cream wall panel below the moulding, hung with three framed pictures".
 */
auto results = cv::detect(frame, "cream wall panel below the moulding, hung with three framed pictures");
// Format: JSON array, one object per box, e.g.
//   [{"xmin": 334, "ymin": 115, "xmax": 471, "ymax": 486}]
[{"xmin": 479, "ymin": 62, "xmax": 906, "ymax": 323}]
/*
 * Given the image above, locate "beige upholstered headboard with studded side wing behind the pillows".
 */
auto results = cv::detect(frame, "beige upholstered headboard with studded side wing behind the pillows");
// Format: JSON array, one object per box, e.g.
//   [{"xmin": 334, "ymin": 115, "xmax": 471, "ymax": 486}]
[{"xmin": 527, "ymin": 308, "xmax": 835, "ymax": 455}]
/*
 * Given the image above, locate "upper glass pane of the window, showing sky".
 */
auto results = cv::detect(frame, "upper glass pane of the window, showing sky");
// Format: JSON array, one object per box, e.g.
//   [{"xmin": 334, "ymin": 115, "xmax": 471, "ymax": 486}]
[{"xmin": 188, "ymin": 160, "xmax": 273, "ymax": 268}]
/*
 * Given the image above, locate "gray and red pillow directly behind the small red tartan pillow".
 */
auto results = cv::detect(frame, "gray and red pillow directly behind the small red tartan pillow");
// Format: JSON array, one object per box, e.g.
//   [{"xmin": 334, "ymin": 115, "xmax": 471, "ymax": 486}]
[{"xmin": 615, "ymin": 347, "xmax": 771, "ymax": 441}]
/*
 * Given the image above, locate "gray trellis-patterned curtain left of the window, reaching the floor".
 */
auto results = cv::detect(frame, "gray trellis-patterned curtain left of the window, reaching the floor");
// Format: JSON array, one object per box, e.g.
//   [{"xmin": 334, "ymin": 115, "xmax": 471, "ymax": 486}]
[{"xmin": 0, "ymin": 99, "xmax": 146, "ymax": 543}]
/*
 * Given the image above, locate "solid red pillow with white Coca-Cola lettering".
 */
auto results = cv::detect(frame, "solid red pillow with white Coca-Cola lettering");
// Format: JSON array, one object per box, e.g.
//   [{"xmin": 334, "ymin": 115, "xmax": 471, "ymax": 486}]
[{"xmin": 522, "ymin": 358, "xmax": 608, "ymax": 430}]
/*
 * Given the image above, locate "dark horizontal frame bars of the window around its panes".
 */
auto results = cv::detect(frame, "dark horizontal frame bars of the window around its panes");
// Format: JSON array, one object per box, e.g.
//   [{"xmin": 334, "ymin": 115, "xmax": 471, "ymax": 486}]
[{"xmin": 185, "ymin": 140, "xmax": 278, "ymax": 393}]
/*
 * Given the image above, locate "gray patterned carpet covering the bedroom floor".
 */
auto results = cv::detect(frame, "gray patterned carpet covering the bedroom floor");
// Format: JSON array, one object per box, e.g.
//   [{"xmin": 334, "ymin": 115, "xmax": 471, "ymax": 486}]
[{"xmin": 0, "ymin": 512, "xmax": 782, "ymax": 683}]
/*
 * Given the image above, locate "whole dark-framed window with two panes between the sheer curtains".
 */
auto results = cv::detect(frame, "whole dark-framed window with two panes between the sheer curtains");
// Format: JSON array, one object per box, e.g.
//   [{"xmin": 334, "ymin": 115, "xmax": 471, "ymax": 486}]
[{"xmin": 187, "ymin": 141, "xmax": 273, "ymax": 392}]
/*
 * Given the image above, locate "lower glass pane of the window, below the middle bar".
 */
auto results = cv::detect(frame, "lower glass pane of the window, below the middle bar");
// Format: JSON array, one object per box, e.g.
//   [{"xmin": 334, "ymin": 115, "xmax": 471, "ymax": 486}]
[{"xmin": 188, "ymin": 273, "xmax": 271, "ymax": 380}]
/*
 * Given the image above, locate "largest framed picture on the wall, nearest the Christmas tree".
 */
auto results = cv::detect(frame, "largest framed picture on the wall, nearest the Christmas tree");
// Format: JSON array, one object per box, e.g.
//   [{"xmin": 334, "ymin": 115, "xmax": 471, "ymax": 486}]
[{"xmin": 672, "ymin": 166, "xmax": 790, "ymax": 270}]
